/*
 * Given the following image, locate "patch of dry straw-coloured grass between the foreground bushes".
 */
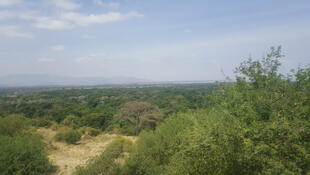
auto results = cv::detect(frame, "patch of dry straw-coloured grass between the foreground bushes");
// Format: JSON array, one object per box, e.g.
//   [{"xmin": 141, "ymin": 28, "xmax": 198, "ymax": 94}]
[{"xmin": 37, "ymin": 128, "xmax": 136, "ymax": 175}]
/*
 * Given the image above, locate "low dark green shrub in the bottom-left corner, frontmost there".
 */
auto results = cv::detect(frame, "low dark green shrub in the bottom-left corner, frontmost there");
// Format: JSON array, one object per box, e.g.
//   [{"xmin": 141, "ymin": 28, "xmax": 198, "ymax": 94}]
[{"xmin": 0, "ymin": 135, "xmax": 52, "ymax": 175}]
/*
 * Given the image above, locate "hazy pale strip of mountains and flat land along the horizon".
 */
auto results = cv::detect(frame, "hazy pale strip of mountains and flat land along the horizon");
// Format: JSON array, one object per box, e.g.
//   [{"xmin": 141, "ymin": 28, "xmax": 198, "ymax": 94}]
[{"xmin": 0, "ymin": 74, "xmax": 223, "ymax": 88}]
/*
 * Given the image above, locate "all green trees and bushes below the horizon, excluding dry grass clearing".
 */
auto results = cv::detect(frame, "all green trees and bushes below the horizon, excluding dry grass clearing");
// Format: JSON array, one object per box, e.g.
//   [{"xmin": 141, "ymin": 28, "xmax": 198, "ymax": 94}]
[{"xmin": 0, "ymin": 47, "xmax": 310, "ymax": 175}]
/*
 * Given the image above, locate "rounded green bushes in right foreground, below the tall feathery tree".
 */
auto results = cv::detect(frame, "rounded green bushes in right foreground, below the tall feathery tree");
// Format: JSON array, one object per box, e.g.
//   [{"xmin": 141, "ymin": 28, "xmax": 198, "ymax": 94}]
[{"xmin": 121, "ymin": 109, "xmax": 310, "ymax": 175}]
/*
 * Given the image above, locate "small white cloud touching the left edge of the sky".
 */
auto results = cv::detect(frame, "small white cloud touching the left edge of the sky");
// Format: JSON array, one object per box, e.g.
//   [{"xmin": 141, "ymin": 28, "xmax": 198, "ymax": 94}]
[{"xmin": 0, "ymin": 25, "xmax": 34, "ymax": 39}]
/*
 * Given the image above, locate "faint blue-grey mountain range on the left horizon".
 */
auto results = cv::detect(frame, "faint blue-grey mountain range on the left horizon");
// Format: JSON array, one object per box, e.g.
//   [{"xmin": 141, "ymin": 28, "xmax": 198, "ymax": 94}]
[{"xmin": 0, "ymin": 74, "xmax": 150, "ymax": 86}]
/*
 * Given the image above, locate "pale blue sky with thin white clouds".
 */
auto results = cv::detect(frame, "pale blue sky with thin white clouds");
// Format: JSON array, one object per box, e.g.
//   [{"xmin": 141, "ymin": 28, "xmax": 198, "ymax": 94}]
[{"xmin": 0, "ymin": 0, "xmax": 310, "ymax": 81}]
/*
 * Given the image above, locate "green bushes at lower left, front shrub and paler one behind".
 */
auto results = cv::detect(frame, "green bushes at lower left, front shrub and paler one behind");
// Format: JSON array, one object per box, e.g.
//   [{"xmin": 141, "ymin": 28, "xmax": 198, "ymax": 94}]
[{"xmin": 0, "ymin": 115, "xmax": 51, "ymax": 175}]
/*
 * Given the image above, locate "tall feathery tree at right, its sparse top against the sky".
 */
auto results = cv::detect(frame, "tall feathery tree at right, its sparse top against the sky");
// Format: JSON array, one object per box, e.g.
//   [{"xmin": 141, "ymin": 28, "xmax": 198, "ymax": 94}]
[{"xmin": 231, "ymin": 46, "xmax": 290, "ymax": 120}]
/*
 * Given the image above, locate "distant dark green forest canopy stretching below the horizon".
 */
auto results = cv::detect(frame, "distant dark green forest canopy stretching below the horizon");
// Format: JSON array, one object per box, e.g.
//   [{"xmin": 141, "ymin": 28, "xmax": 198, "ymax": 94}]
[{"xmin": 0, "ymin": 84, "xmax": 215, "ymax": 132}]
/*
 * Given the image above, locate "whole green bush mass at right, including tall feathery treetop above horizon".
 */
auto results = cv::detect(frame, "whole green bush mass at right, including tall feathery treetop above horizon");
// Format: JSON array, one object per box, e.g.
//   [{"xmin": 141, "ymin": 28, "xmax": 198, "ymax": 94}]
[{"xmin": 120, "ymin": 48, "xmax": 310, "ymax": 175}]
